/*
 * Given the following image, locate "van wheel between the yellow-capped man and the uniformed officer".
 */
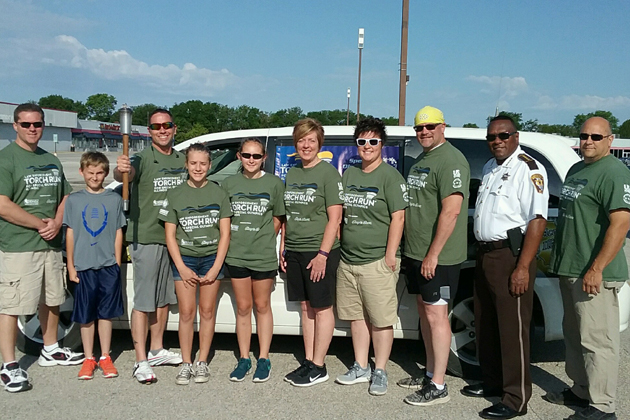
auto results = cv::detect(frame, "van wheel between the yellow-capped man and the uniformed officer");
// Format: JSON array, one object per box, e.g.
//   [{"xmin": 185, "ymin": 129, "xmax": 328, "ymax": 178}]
[{"xmin": 447, "ymin": 290, "xmax": 481, "ymax": 379}]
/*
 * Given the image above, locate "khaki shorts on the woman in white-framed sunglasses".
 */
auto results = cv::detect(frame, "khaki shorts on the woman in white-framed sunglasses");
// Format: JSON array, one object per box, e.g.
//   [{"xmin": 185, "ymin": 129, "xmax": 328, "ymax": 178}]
[{"xmin": 337, "ymin": 258, "xmax": 400, "ymax": 328}]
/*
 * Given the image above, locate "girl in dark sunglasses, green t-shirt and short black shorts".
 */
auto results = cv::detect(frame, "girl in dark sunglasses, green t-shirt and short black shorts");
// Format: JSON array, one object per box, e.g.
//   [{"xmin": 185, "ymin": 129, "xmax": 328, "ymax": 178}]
[{"xmin": 223, "ymin": 138, "xmax": 284, "ymax": 382}]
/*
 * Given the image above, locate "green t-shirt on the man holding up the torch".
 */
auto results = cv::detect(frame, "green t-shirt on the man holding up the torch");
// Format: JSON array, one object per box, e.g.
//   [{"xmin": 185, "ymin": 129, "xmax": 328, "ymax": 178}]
[{"xmin": 127, "ymin": 146, "xmax": 188, "ymax": 245}]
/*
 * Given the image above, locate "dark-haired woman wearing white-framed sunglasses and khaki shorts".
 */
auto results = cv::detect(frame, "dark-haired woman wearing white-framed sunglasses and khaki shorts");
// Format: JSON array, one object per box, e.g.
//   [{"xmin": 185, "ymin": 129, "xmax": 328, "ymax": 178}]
[{"xmin": 337, "ymin": 118, "xmax": 407, "ymax": 395}]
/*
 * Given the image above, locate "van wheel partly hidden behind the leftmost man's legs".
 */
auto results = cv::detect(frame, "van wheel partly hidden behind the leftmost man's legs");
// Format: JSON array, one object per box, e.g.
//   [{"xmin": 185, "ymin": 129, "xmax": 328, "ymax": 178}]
[{"xmin": 16, "ymin": 290, "xmax": 81, "ymax": 356}]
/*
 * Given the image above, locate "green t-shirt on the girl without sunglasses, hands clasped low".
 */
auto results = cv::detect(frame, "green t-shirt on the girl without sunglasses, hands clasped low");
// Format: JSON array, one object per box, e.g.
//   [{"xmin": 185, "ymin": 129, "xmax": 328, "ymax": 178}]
[{"xmin": 158, "ymin": 181, "xmax": 232, "ymax": 257}]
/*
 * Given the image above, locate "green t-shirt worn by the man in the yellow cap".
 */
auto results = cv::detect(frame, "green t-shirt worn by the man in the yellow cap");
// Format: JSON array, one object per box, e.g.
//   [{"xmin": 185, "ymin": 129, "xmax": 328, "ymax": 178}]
[{"xmin": 403, "ymin": 141, "xmax": 470, "ymax": 265}]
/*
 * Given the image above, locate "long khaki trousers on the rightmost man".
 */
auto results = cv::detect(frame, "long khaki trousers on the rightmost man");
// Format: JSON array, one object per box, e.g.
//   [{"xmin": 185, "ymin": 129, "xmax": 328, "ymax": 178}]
[{"xmin": 560, "ymin": 277, "xmax": 623, "ymax": 413}]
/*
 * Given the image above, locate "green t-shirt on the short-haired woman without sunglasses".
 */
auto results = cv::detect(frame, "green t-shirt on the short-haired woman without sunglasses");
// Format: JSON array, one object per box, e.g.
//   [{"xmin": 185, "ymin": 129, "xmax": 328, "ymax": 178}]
[{"xmin": 284, "ymin": 161, "xmax": 343, "ymax": 252}]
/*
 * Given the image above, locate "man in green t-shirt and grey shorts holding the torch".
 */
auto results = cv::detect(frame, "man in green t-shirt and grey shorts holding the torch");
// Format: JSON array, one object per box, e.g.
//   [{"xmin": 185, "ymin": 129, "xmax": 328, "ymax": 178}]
[{"xmin": 114, "ymin": 109, "xmax": 186, "ymax": 383}]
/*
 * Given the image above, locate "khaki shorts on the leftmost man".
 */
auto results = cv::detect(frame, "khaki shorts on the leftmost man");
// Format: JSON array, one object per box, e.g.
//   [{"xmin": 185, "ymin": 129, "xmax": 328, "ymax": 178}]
[{"xmin": 0, "ymin": 250, "xmax": 66, "ymax": 315}]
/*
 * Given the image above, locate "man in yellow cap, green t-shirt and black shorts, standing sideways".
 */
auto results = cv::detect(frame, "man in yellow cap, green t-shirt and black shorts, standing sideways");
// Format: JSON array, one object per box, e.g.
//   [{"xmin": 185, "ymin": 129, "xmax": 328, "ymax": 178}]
[{"xmin": 398, "ymin": 106, "xmax": 470, "ymax": 406}]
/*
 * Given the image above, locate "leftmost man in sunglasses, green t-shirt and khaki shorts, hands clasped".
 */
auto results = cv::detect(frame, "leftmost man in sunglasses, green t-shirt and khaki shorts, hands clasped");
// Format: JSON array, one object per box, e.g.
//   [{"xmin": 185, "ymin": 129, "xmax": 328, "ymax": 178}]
[{"xmin": 0, "ymin": 103, "xmax": 84, "ymax": 392}]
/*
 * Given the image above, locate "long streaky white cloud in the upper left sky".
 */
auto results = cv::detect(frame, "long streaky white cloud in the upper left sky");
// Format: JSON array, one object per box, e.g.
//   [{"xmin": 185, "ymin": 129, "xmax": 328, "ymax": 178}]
[{"xmin": 40, "ymin": 35, "xmax": 239, "ymax": 96}]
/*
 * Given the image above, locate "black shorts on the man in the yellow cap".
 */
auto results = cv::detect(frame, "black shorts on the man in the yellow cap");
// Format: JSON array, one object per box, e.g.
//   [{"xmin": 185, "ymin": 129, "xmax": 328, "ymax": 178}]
[{"xmin": 404, "ymin": 257, "xmax": 462, "ymax": 303}]
